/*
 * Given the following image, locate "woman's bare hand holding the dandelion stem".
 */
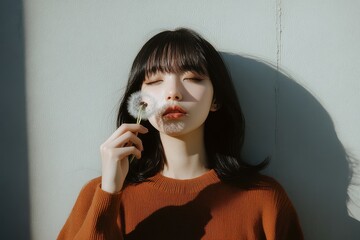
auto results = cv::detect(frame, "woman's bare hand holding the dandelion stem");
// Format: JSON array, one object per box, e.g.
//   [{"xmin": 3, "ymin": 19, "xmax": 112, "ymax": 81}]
[{"xmin": 100, "ymin": 124, "xmax": 148, "ymax": 193}]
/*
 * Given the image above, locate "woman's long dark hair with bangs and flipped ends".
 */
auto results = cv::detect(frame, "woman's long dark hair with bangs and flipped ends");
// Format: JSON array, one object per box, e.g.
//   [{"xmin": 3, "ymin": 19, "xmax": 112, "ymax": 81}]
[{"xmin": 117, "ymin": 28, "xmax": 268, "ymax": 186}]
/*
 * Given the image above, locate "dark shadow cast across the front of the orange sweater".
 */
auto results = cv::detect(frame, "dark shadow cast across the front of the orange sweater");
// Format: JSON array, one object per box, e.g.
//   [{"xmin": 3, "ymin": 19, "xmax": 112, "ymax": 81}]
[{"xmin": 125, "ymin": 183, "xmax": 233, "ymax": 240}]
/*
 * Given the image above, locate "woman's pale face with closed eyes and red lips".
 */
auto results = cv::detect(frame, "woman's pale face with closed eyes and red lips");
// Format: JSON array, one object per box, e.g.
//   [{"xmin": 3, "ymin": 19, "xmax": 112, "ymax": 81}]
[{"xmin": 141, "ymin": 71, "xmax": 214, "ymax": 136}]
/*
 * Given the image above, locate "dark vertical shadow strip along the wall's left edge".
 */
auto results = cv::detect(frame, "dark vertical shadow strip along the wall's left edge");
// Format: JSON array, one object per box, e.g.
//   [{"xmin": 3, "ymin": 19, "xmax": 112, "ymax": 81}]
[{"xmin": 0, "ymin": 0, "xmax": 30, "ymax": 239}]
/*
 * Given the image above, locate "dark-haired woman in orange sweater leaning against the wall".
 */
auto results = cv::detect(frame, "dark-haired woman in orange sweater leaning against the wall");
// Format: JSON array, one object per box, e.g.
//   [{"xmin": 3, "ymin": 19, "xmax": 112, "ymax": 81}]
[{"xmin": 58, "ymin": 29, "xmax": 303, "ymax": 240}]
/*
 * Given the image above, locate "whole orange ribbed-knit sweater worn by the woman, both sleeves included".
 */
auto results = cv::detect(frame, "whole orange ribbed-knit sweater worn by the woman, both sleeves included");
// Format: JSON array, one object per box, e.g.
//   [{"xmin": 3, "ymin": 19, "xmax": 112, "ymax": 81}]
[{"xmin": 58, "ymin": 170, "xmax": 303, "ymax": 240}]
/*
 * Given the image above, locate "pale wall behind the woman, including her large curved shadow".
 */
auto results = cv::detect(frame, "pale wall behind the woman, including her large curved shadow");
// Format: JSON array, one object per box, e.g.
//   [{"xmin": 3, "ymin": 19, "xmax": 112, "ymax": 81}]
[{"xmin": 24, "ymin": 0, "xmax": 360, "ymax": 239}]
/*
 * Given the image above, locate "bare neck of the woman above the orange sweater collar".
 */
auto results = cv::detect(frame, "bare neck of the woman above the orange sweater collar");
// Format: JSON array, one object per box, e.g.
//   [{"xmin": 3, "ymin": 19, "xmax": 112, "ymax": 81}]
[{"xmin": 160, "ymin": 127, "xmax": 208, "ymax": 179}]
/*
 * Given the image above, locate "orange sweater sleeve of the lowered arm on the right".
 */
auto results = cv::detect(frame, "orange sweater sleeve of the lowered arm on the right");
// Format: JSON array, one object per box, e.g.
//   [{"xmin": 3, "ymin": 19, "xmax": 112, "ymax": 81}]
[{"xmin": 263, "ymin": 180, "xmax": 304, "ymax": 240}]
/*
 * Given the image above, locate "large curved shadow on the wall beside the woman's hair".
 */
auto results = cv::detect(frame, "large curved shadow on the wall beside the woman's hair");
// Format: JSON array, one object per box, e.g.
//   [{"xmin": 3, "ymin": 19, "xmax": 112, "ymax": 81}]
[{"xmin": 221, "ymin": 53, "xmax": 360, "ymax": 240}]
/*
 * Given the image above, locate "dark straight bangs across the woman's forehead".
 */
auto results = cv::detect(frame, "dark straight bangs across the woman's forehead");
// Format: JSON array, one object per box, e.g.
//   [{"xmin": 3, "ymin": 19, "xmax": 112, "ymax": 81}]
[{"xmin": 144, "ymin": 36, "xmax": 208, "ymax": 76}]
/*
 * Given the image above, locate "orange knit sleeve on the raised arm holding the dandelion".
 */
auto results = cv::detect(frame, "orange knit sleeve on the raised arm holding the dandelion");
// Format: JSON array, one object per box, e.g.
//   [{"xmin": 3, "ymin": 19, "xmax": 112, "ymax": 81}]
[{"xmin": 57, "ymin": 178, "xmax": 122, "ymax": 240}]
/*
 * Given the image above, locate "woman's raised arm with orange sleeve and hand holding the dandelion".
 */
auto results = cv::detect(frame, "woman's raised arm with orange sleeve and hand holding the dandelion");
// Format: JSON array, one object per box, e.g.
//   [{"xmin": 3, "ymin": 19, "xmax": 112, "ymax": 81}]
[{"xmin": 58, "ymin": 124, "xmax": 148, "ymax": 240}]
